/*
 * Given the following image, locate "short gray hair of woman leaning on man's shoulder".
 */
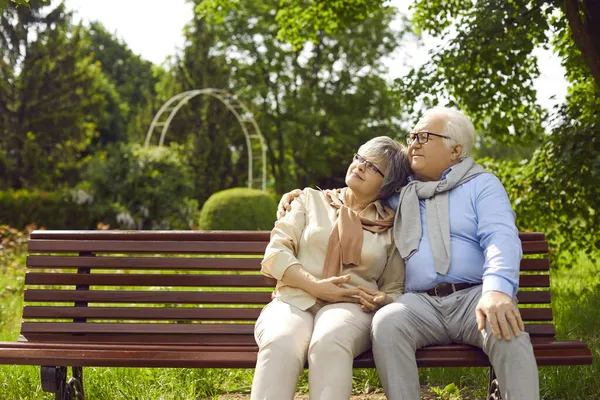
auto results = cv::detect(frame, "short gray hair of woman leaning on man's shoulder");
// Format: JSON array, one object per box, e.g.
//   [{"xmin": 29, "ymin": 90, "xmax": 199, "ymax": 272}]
[{"xmin": 358, "ymin": 136, "xmax": 411, "ymax": 199}]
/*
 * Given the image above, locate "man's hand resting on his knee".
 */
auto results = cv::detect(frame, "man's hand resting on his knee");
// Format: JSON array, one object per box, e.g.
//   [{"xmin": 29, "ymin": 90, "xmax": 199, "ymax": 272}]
[{"xmin": 475, "ymin": 290, "xmax": 525, "ymax": 340}]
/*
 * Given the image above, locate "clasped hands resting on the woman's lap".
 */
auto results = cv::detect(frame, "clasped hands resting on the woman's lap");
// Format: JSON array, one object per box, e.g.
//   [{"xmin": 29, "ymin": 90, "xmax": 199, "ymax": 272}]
[{"xmin": 311, "ymin": 275, "xmax": 388, "ymax": 312}]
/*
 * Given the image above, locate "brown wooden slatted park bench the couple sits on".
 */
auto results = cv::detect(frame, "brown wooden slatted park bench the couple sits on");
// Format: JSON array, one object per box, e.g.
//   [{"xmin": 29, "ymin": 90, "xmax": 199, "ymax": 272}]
[{"xmin": 0, "ymin": 231, "xmax": 592, "ymax": 399}]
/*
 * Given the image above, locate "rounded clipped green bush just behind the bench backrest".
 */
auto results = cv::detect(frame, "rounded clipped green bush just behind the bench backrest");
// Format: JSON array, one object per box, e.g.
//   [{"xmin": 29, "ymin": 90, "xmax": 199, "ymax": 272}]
[{"xmin": 198, "ymin": 188, "xmax": 277, "ymax": 230}]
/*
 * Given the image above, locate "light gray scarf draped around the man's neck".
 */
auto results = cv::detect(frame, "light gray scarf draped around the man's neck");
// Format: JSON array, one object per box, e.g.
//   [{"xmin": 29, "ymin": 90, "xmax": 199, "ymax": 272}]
[{"xmin": 394, "ymin": 157, "xmax": 485, "ymax": 275}]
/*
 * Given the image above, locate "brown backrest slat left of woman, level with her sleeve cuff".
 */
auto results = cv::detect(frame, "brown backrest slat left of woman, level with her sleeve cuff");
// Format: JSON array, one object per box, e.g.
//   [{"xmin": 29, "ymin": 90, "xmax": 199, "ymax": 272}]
[{"xmin": 25, "ymin": 272, "xmax": 277, "ymax": 288}]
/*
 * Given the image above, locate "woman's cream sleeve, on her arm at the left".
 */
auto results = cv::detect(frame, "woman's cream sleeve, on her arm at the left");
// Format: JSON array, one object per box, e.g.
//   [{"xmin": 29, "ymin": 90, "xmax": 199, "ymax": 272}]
[{"xmin": 260, "ymin": 193, "xmax": 306, "ymax": 281}]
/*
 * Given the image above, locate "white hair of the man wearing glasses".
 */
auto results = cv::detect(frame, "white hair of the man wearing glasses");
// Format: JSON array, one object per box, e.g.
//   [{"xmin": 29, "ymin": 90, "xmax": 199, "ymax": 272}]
[{"xmin": 422, "ymin": 107, "xmax": 475, "ymax": 160}]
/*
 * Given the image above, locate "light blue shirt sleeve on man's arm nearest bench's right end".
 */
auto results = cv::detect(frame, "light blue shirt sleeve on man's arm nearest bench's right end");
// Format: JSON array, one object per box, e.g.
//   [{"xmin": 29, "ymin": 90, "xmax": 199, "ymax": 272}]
[{"xmin": 475, "ymin": 174, "xmax": 523, "ymax": 297}]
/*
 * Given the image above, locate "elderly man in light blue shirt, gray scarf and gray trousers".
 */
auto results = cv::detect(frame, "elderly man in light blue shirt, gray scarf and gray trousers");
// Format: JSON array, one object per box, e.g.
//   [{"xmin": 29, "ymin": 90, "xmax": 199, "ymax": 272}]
[{"xmin": 372, "ymin": 108, "xmax": 539, "ymax": 400}]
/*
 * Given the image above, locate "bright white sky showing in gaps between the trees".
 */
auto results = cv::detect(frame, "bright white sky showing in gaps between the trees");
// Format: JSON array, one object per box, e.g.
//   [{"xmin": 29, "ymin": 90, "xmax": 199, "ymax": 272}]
[{"xmin": 65, "ymin": 0, "xmax": 567, "ymax": 109}]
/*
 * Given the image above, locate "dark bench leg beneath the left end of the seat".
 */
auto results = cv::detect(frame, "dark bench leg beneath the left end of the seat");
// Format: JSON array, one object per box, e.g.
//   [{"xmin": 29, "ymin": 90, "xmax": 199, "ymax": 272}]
[{"xmin": 40, "ymin": 367, "xmax": 85, "ymax": 400}]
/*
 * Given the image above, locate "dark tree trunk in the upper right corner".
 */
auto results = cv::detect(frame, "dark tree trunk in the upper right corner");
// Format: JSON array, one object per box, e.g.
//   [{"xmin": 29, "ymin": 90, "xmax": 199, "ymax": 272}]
[{"xmin": 565, "ymin": 0, "xmax": 600, "ymax": 92}]
